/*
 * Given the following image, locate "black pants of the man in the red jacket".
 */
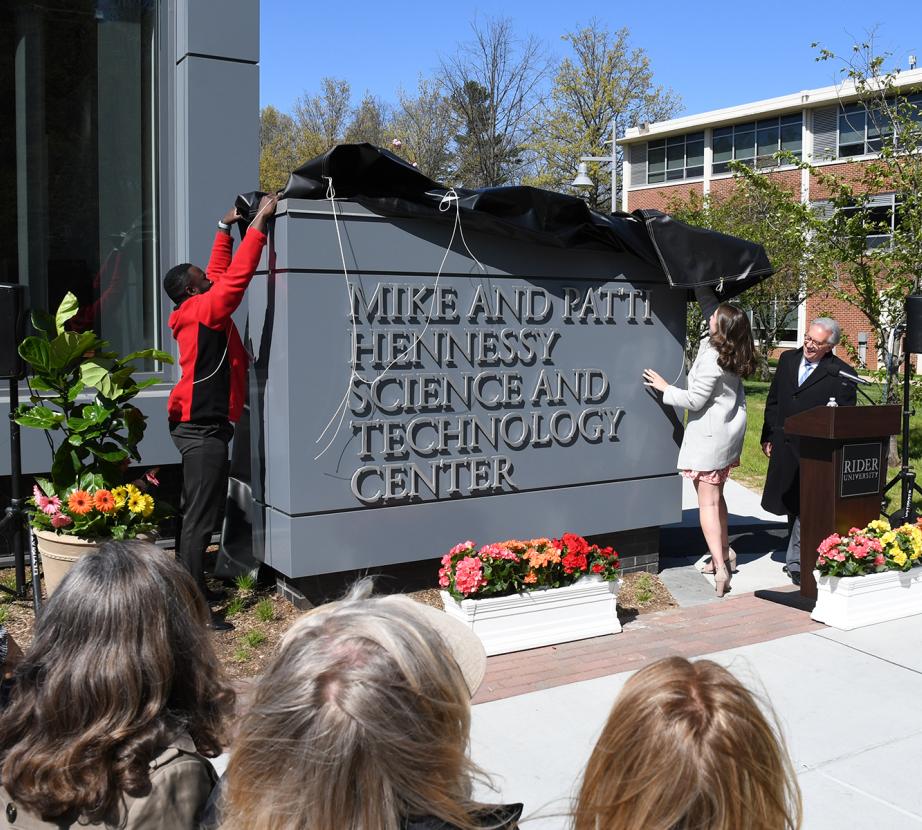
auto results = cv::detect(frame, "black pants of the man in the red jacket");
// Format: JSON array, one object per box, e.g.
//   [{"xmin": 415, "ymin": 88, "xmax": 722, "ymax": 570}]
[{"xmin": 170, "ymin": 421, "xmax": 234, "ymax": 589}]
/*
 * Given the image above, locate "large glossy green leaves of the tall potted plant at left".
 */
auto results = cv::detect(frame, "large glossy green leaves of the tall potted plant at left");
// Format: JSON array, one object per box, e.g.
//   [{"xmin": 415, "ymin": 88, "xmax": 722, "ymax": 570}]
[{"xmin": 15, "ymin": 292, "xmax": 173, "ymax": 493}]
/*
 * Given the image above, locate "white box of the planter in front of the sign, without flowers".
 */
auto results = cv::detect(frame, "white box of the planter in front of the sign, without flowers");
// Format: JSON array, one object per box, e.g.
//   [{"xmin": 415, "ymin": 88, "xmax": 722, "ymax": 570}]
[{"xmin": 441, "ymin": 575, "xmax": 621, "ymax": 655}]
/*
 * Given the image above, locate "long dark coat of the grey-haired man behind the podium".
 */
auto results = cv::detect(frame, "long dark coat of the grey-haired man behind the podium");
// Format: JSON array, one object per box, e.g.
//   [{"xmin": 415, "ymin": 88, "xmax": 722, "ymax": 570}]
[{"xmin": 761, "ymin": 349, "xmax": 858, "ymax": 516}]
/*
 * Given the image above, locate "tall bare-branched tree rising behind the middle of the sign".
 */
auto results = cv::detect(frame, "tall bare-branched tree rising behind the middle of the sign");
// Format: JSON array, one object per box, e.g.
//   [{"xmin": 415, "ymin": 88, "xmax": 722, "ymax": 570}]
[{"xmin": 440, "ymin": 19, "xmax": 548, "ymax": 187}]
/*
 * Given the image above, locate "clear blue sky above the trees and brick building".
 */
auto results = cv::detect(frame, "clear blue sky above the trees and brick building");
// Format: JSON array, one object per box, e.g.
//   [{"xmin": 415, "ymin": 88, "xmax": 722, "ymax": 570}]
[{"xmin": 260, "ymin": 0, "xmax": 922, "ymax": 122}]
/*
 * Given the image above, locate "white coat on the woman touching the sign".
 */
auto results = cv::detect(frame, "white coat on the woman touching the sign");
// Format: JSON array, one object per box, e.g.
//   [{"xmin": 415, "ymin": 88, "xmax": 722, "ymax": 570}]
[{"xmin": 663, "ymin": 338, "xmax": 746, "ymax": 471}]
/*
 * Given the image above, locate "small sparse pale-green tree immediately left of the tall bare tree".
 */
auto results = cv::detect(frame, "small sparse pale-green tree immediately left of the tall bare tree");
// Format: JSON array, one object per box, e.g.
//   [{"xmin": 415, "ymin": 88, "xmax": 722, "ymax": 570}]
[{"xmin": 391, "ymin": 77, "xmax": 452, "ymax": 181}]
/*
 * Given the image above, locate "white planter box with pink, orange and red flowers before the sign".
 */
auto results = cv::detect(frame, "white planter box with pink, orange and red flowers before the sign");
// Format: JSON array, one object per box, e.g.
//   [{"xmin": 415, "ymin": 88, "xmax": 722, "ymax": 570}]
[{"xmin": 439, "ymin": 533, "xmax": 621, "ymax": 654}]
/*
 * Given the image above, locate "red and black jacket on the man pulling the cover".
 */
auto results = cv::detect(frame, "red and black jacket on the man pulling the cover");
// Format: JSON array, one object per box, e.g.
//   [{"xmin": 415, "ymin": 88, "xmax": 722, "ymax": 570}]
[{"xmin": 167, "ymin": 228, "xmax": 266, "ymax": 421}]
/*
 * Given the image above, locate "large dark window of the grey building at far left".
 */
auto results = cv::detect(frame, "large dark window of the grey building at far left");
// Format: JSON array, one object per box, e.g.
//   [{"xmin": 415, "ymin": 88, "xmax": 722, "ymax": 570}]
[{"xmin": 0, "ymin": 0, "xmax": 160, "ymax": 368}]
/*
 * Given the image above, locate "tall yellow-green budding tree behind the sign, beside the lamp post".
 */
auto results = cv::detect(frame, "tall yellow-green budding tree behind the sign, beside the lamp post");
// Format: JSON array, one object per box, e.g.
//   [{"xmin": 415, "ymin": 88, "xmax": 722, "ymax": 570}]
[{"xmin": 530, "ymin": 20, "xmax": 681, "ymax": 213}]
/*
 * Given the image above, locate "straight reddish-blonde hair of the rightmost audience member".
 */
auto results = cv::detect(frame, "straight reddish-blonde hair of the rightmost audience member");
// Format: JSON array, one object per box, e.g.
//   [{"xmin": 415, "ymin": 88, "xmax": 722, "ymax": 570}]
[{"xmin": 574, "ymin": 657, "xmax": 802, "ymax": 830}]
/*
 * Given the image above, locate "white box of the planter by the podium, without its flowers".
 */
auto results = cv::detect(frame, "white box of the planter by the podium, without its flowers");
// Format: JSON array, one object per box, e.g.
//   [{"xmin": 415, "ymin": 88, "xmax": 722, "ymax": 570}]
[{"xmin": 810, "ymin": 568, "xmax": 922, "ymax": 631}]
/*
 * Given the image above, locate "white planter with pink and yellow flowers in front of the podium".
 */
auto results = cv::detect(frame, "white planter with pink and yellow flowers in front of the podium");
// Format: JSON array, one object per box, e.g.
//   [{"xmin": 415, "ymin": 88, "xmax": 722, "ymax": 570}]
[{"xmin": 811, "ymin": 519, "xmax": 922, "ymax": 631}]
